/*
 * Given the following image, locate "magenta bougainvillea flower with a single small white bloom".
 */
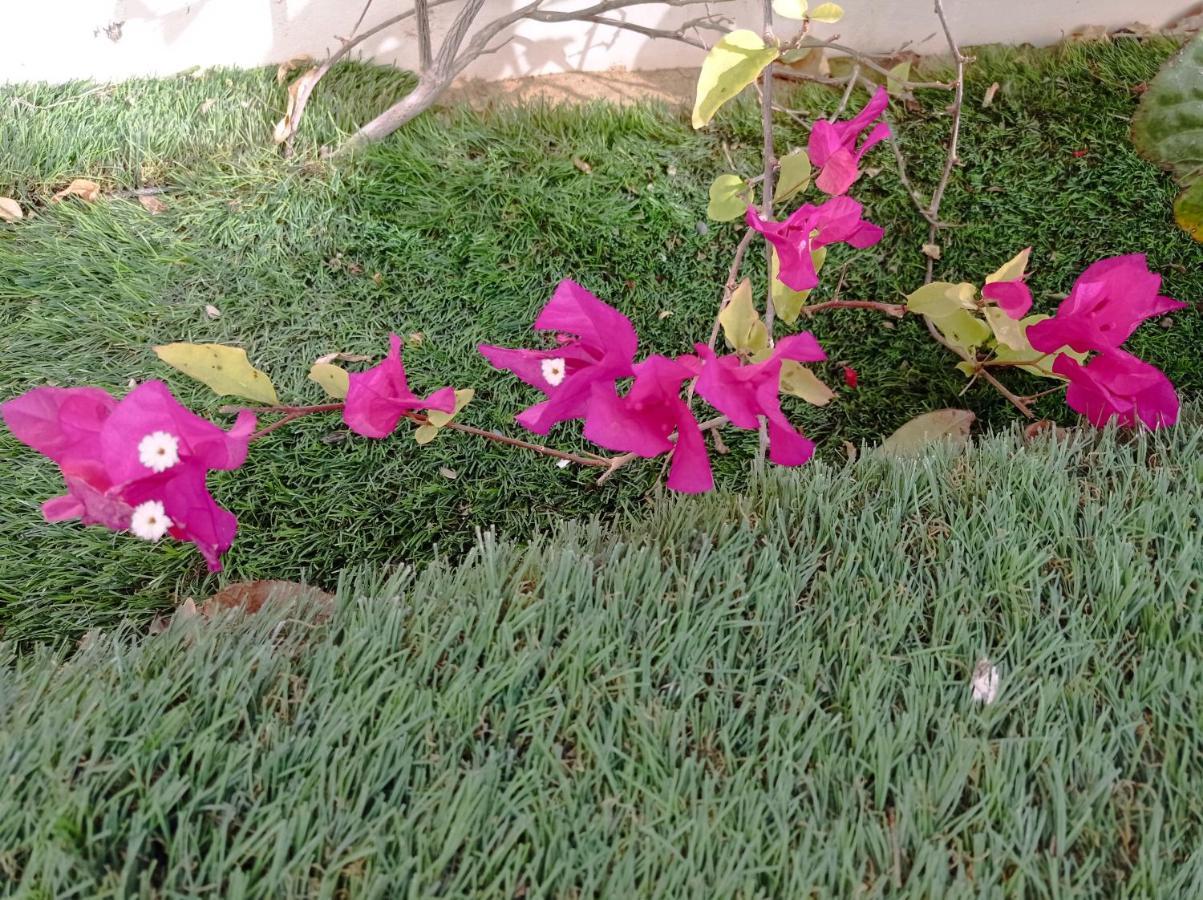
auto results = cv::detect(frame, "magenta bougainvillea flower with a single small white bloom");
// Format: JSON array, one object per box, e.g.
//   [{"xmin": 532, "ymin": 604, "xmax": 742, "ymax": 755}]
[{"xmin": 476, "ymin": 278, "xmax": 639, "ymax": 434}]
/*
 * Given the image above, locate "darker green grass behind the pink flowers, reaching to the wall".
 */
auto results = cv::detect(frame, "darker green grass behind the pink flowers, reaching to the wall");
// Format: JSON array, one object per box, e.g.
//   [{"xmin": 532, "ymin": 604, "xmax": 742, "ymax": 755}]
[{"xmin": 0, "ymin": 41, "xmax": 1203, "ymax": 640}]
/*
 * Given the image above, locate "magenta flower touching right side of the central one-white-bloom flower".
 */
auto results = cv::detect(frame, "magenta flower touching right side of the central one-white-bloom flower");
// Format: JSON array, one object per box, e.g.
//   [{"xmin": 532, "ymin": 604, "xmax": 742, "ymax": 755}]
[{"xmin": 585, "ymin": 355, "xmax": 715, "ymax": 493}]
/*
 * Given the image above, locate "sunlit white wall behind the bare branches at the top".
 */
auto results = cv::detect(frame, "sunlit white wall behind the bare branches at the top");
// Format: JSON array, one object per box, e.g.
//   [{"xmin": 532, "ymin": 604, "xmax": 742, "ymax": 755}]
[{"xmin": 0, "ymin": 0, "xmax": 1197, "ymax": 82}]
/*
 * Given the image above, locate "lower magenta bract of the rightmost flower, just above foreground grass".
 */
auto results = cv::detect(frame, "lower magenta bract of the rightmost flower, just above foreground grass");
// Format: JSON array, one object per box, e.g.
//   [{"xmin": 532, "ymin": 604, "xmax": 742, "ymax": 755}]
[{"xmin": 1053, "ymin": 350, "xmax": 1178, "ymax": 428}]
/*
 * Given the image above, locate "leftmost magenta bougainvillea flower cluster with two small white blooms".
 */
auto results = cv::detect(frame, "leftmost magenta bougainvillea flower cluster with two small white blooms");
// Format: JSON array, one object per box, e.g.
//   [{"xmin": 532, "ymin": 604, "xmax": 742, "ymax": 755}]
[{"xmin": 0, "ymin": 381, "xmax": 255, "ymax": 572}]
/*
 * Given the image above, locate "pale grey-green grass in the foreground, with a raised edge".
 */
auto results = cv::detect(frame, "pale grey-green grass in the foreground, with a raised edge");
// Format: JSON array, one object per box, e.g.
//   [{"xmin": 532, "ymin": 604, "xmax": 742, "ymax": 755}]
[{"xmin": 0, "ymin": 426, "xmax": 1203, "ymax": 898}]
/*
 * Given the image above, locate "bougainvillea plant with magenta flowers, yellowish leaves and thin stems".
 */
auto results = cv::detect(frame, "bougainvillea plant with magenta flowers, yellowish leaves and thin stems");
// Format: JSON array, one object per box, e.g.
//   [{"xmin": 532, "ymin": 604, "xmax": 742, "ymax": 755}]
[{"xmin": 0, "ymin": 0, "xmax": 1185, "ymax": 570}]
